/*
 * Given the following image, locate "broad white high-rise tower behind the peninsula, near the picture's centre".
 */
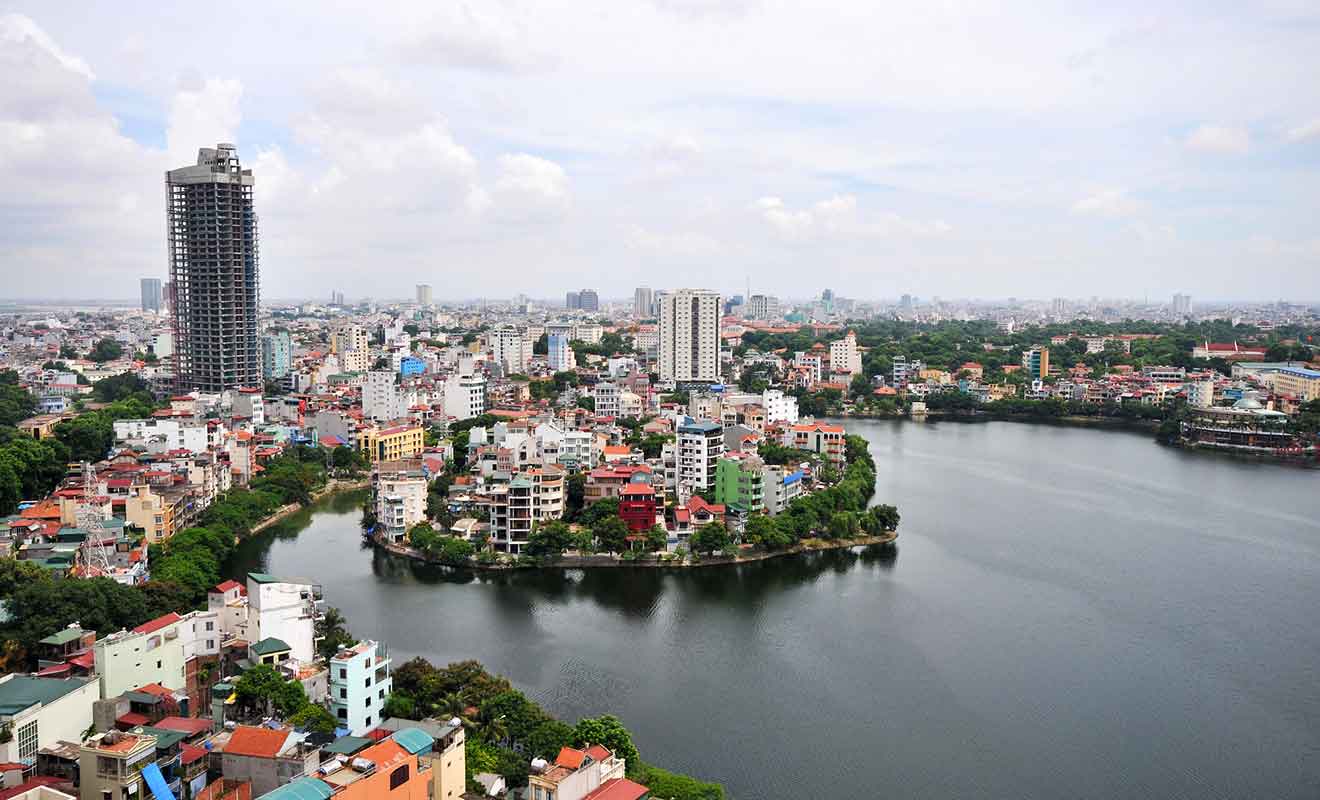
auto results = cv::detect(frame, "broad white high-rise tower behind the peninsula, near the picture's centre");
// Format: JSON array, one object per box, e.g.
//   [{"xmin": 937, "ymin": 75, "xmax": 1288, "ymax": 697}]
[{"xmin": 660, "ymin": 289, "xmax": 719, "ymax": 383}]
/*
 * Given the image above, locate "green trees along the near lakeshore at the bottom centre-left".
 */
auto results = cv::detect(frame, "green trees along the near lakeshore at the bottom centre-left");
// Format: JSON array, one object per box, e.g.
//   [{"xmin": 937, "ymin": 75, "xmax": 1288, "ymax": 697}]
[{"xmin": 384, "ymin": 659, "xmax": 725, "ymax": 800}]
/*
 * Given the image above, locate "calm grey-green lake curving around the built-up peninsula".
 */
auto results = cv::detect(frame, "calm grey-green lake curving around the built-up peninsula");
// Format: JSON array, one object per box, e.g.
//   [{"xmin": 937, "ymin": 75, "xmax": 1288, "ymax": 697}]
[{"xmin": 232, "ymin": 421, "xmax": 1320, "ymax": 800}]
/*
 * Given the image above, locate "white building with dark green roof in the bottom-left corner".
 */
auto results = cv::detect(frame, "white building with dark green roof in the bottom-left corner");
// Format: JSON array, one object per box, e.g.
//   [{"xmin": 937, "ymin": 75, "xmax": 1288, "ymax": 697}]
[{"xmin": 0, "ymin": 675, "xmax": 100, "ymax": 764}]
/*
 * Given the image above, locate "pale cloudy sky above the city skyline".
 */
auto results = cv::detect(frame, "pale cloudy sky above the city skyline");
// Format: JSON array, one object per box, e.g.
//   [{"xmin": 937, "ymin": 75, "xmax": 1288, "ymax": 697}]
[{"xmin": 0, "ymin": 0, "xmax": 1320, "ymax": 301}]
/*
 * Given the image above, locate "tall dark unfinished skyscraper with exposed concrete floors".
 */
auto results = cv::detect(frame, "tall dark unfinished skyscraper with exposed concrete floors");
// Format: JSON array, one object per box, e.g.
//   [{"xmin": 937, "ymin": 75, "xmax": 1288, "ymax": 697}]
[{"xmin": 165, "ymin": 143, "xmax": 261, "ymax": 392}]
